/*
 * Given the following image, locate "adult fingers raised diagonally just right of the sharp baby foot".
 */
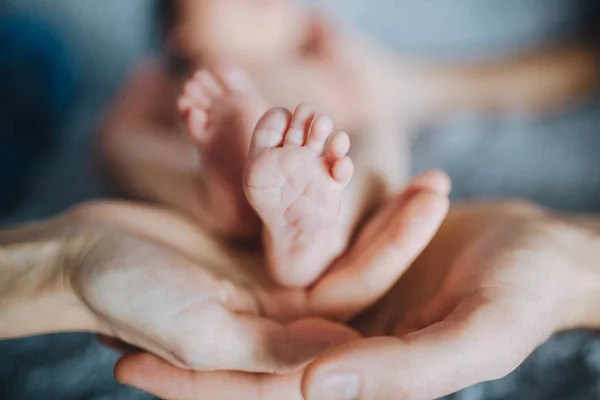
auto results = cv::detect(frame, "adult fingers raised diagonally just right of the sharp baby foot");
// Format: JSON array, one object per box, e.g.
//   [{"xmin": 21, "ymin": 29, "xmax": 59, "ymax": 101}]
[{"xmin": 309, "ymin": 171, "xmax": 449, "ymax": 320}]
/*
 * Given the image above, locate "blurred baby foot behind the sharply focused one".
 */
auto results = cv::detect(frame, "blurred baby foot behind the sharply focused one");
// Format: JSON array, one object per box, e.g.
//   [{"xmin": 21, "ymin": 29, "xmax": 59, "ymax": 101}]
[{"xmin": 178, "ymin": 64, "xmax": 268, "ymax": 236}]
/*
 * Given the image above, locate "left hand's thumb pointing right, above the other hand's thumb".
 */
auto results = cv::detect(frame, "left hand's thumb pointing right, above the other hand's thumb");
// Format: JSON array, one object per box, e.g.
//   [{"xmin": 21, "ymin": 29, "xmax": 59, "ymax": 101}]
[{"xmin": 170, "ymin": 306, "xmax": 358, "ymax": 373}]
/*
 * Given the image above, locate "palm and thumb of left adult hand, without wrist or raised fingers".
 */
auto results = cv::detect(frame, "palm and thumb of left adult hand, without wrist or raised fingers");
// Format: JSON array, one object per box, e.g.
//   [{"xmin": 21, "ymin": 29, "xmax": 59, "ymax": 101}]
[{"xmin": 66, "ymin": 203, "xmax": 364, "ymax": 373}]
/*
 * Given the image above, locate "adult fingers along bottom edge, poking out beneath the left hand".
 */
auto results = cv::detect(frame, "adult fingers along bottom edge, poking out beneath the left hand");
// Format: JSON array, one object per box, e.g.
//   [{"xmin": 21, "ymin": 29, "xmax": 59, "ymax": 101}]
[{"xmin": 115, "ymin": 354, "xmax": 303, "ymax": 400}]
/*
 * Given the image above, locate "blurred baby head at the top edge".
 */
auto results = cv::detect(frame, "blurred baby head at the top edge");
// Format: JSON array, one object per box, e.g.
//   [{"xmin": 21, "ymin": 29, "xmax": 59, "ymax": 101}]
[{"xmin": 157, "ymin": 0, "xmax": 306, "ymax": 66}]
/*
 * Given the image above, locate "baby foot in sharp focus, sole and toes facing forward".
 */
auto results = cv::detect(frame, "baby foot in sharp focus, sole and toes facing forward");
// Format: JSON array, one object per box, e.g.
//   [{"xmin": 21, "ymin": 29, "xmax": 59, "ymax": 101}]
[{"xmin": 244, "ymin": 105, "xmax": 354, "ymax": 287}]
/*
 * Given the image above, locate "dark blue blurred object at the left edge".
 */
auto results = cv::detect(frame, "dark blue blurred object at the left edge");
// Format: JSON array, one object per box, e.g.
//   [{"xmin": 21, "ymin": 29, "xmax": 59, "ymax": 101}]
[{"xmin": 0, "ymin": 12, "xmax": 75, "ymax": 215}]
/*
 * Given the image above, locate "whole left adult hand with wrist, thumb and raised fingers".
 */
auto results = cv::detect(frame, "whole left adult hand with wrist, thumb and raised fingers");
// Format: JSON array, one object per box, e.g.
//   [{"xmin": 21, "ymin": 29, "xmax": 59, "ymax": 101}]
[{"xmin": 0, "ymin": 173, "xmax": 449, "ymax": 377}]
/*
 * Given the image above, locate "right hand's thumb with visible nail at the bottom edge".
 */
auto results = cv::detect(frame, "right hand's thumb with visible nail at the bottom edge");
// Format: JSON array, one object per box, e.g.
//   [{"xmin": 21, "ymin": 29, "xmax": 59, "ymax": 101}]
[{"xmin": 302, "ymin": 299, "xmax": 549, "ymax": 400}]
